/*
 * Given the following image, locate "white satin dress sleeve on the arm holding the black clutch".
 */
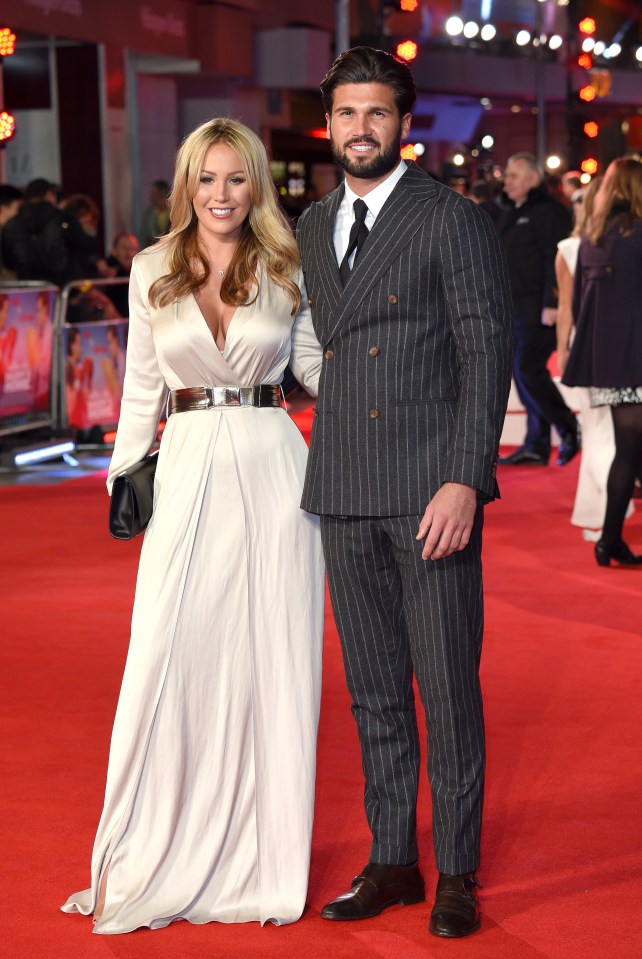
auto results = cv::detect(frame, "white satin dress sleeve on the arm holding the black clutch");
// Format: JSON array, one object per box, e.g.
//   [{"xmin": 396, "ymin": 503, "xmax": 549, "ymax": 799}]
[{"xmin": 107, "ymin": 260, "xmax": 165, "ymax": 494}]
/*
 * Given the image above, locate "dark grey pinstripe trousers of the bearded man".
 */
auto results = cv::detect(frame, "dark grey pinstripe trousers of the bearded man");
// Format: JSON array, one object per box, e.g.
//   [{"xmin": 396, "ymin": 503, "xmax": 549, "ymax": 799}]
[{"xmin": 321, "ymin": 507, "xmax": 485, "ymax": 875}]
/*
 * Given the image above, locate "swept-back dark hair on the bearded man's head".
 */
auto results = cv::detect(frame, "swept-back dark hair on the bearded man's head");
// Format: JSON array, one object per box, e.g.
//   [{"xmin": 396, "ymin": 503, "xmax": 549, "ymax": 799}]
[{"xmin": 321, "ymin": 47, "xmax": 417, "ymax": 117}]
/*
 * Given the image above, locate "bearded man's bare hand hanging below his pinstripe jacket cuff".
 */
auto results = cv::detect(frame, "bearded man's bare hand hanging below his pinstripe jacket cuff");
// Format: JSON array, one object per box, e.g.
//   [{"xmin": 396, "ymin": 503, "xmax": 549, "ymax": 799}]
[{"xmin": 417, "ymin": 483, "xmax": 477, "ymax": 559}]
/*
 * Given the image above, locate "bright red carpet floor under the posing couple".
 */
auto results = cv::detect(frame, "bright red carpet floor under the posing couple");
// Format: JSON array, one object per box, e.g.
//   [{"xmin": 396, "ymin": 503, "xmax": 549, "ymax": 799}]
[{"xmin": 0, "ymin": 430, "xmax": 642, "ymax": 959}]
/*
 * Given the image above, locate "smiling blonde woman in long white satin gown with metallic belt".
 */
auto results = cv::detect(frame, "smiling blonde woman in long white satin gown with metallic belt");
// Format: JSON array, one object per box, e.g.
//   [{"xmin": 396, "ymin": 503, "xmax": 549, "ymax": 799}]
[{"xmin": 62, "ymin": 120, "xmax": 324, "ymax": 933}]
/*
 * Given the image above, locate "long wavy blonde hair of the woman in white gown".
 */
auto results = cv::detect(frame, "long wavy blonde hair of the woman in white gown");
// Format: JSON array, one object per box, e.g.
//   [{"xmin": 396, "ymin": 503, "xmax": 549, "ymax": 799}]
[{"xmin": 149, "ymin": 117, "xmax": 301, "ymax": 314}]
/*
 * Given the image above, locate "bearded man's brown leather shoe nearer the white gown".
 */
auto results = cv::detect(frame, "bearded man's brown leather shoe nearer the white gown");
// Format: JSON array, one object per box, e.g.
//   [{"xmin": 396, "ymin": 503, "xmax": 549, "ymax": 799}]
[{"xmin": 321, "ymin": 862, "xmax": 426, "ymax": 919}]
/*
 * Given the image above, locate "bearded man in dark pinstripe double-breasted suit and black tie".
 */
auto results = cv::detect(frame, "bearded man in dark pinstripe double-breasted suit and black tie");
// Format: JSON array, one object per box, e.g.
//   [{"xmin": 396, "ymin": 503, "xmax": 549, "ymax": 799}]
[{"xmin": 298, "ymin": 47, "xmax": 512, "ymax": 937}]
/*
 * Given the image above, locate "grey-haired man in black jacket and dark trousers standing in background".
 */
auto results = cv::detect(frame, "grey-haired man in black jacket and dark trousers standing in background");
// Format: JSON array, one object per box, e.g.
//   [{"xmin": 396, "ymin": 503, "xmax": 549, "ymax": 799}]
[{"xmin": 498, "ymin": 153, "xmax": 579, "ymax": 466}]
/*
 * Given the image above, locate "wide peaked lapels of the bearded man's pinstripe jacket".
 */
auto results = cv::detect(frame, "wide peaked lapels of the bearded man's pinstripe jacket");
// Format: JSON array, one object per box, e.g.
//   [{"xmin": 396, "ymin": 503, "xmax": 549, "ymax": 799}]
[{"xmin": 326, "ymin": 164, "xmax": 437, "ymax": 340}]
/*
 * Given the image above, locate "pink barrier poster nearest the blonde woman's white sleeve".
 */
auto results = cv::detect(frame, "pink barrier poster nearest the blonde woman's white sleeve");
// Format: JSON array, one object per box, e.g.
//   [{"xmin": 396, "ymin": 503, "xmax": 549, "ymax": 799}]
[{"xmin": 63, "ymin": 320, "xmax": 127, "ymax": 430}]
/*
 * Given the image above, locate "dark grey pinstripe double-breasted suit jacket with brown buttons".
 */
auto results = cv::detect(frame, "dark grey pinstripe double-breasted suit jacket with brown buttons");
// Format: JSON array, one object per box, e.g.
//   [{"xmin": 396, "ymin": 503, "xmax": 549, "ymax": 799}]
[{"xmin": 297, "ymin": 164, "xmax": 512, "ymax": 516}]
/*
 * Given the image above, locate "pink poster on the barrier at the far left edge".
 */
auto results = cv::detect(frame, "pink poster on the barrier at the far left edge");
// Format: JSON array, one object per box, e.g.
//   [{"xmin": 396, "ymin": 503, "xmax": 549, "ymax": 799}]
[{"xmin": 0, "ymin": 289, "xmax": 56, "ymax": 420}]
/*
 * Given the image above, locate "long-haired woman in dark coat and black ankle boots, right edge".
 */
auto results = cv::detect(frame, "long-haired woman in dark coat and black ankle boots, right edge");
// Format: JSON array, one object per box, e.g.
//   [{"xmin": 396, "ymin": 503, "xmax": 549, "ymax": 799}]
[{"xmin": 563, "ymin": 157, "xmax": 642, "ymax": 566}]
